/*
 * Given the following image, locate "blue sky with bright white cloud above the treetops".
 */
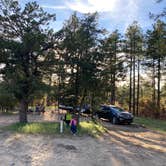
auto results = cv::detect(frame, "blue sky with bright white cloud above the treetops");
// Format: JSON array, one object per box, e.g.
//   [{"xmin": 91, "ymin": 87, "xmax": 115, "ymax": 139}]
[{"xmin": 18, "ymin": 0, "xmax": 166, "ymax": 34}]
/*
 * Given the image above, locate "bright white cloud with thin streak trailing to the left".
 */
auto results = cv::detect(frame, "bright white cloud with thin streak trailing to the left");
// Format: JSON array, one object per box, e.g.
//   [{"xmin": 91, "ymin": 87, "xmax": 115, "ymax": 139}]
[{"xmin": 42, "ymin": 0, "xmax": 139, "ymax": 21}]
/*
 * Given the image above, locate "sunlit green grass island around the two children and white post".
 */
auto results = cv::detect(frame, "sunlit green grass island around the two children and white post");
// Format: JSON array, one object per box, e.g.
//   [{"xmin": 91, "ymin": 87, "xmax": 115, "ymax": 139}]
[{"xmin": 4, "ymin": 121, "xmax": 106, "ymax": 137}]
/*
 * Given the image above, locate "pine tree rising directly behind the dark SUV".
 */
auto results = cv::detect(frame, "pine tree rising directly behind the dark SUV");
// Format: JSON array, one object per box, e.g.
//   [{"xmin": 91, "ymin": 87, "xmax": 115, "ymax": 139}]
[{"xmin": 102, "ymin": 30, "xmax": 125, "ymax": 104}]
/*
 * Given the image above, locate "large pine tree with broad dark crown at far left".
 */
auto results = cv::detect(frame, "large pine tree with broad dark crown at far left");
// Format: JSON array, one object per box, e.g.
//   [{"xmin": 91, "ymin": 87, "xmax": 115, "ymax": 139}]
[{"xmin": 0, "ymin": 0, "xmax": 55, "ymax": 122}]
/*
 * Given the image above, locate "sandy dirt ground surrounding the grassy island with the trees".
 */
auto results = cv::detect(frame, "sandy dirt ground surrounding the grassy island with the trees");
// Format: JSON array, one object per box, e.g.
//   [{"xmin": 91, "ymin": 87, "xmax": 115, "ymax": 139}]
[{"xmin": 0, "ymin": 114, "xmax": 166, "ymax": 166}]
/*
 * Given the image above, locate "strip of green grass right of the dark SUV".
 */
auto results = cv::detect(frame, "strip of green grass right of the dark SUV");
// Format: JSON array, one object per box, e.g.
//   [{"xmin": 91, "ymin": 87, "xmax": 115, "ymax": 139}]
[{"xmin": 134, "ymin": 117, "xmax": 166, "ymax": 133}]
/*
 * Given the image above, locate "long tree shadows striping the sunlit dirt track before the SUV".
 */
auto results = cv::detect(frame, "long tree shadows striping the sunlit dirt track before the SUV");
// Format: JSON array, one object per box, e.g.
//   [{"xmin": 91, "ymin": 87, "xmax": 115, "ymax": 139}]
[{"xmin": 102, "ymin": 123, "xmax": 166, "ymax": 153}]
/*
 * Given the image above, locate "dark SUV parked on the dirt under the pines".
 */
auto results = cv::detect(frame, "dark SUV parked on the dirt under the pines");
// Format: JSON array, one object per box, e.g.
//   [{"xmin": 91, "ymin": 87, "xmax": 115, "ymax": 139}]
[{"xmin": 97, "ymin": 105, "xmax": 134, "ymax": 124}]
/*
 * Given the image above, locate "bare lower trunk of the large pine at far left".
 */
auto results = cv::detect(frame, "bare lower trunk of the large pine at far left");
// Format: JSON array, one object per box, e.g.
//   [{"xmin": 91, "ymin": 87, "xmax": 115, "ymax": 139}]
[{"xmin": 19, "ymin": 99, "xmax": 28, "ymax": 123}]
